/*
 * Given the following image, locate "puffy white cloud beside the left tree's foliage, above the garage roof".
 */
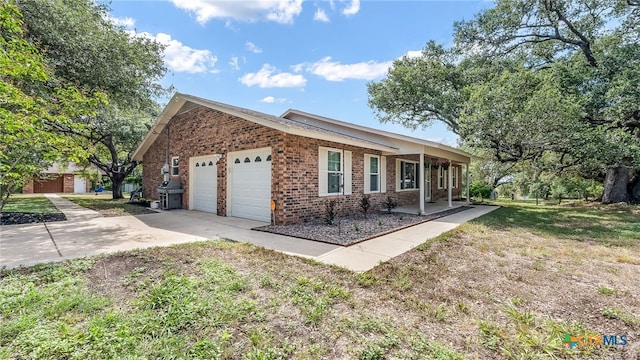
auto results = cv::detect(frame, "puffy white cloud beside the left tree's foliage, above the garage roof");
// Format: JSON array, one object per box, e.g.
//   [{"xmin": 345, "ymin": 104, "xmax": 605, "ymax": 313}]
[{"xmin": 134, "ymin": 32, "xmax": 219, "ymax": 74}]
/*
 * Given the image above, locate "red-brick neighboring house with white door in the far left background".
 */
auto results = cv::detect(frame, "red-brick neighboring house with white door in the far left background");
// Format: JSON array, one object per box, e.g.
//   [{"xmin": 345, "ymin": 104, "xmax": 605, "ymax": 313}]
[{"xmin": 22, "ymin": 162, "xmax": 91, "ymax": 194}]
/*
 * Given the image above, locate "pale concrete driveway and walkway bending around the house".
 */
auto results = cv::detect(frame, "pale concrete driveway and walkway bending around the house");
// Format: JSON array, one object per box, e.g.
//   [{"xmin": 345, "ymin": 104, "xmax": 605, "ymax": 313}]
[{"xmin": 0, "ymin": 194, "xmax": 497, "ymax": 271}]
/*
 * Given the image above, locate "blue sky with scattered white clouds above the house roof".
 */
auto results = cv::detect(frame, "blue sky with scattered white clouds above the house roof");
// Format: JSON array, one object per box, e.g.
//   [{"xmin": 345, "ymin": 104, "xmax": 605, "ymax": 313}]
[{"xmin": 110, "ymin": 0, "xmax": 491, "ymax": 145}]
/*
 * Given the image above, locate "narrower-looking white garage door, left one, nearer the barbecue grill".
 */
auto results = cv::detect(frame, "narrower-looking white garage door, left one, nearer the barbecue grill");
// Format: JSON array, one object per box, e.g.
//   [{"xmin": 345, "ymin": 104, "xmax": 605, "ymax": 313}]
[{"xmin": 189, "ymin": 155, "xmax": 218, "ymax": 213}]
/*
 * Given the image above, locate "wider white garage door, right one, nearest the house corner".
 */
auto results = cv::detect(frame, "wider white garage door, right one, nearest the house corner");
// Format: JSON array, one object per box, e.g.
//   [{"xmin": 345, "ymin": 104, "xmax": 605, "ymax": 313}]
[{"xmin": 229, "ymin": 148, "xmax": 271, "ymax": 221}]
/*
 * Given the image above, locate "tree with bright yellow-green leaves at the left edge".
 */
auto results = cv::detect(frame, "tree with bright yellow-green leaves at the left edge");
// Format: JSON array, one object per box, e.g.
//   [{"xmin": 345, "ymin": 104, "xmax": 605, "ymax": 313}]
[{"xmin": 0, "ymin": 1, "xmax": 103, "ymax": 210}]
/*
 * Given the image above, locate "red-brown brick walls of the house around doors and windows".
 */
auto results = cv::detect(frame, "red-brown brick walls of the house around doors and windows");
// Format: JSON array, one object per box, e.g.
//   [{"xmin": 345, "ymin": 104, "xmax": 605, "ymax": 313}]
[{"xmin": 142, "ymin": 107, "xmax": 462, "ymax": 224}]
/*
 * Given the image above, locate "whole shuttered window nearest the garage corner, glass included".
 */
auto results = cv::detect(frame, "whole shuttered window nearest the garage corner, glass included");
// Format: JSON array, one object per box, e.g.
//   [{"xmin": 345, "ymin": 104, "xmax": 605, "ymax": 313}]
[{"xmin": 318, "ymin": 147, "xmax": 352, "ymax": 196}]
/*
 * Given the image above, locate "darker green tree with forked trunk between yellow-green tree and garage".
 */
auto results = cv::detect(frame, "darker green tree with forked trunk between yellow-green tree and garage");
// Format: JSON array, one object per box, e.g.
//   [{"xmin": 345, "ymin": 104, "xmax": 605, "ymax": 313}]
[{"xmin": 18, "ymin": 0, "xmax": 166, "ymax": 199}]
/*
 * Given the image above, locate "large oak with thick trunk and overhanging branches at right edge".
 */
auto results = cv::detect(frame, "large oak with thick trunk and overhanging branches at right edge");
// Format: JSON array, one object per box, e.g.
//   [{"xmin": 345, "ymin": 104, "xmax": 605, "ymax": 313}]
[{"xmin": 455, "ymin": 0, "xmax": 640, "ymax": 203}]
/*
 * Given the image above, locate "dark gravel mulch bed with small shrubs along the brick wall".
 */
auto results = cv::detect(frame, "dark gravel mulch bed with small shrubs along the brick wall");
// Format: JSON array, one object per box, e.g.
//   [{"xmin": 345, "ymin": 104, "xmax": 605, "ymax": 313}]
[{"xmin": 252, "ymin": 206, "xmax": 472, "ymax": 246}]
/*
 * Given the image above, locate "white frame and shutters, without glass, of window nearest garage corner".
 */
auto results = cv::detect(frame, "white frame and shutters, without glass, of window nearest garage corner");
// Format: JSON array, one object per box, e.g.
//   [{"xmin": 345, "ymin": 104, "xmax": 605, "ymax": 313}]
[{"xmin": 318, "ymin": 146, "xmax": 352, "ymax": 196}]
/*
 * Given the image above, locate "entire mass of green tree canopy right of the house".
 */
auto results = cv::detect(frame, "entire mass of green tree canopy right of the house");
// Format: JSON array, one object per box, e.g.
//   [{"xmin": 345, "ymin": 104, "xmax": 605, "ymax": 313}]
[{"xmin": 368, "ymin": 0, "xmax": 640, "ymax": 202}]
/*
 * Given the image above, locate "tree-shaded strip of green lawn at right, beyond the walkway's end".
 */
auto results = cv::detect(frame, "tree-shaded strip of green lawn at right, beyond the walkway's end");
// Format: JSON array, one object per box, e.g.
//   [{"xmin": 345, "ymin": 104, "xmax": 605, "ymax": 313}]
[{"xmin": 472, "ymin": 204, "xmax": 640, "ymax": 247}]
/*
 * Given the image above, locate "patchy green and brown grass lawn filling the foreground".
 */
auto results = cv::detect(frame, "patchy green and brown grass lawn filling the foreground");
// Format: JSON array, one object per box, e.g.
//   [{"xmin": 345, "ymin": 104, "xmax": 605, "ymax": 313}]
[{"xmin": 0, "ymin": 204, "xmax": 640, "ymax": 359}]
